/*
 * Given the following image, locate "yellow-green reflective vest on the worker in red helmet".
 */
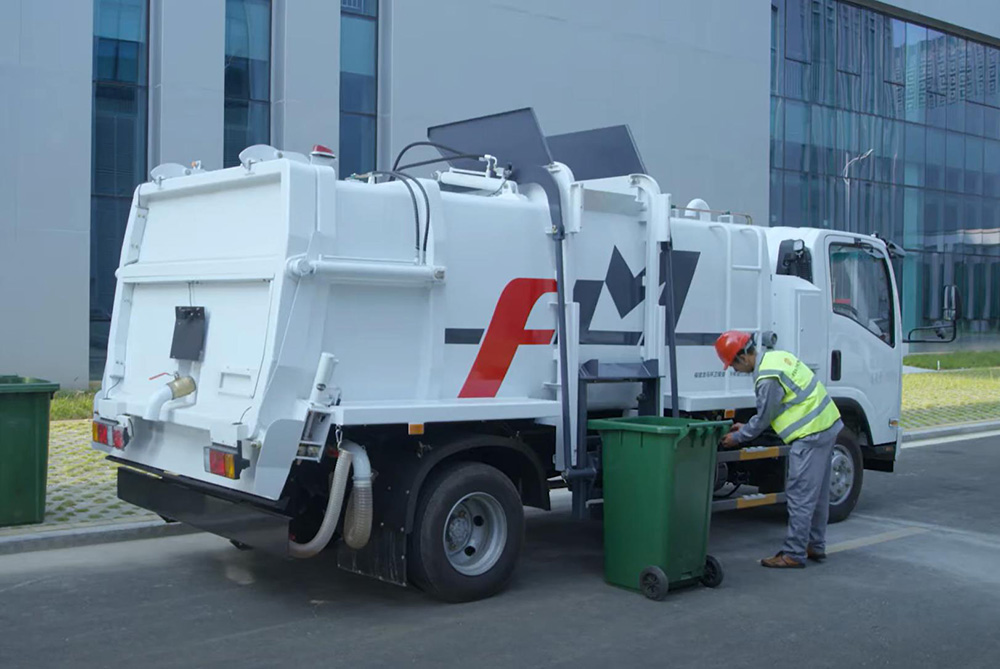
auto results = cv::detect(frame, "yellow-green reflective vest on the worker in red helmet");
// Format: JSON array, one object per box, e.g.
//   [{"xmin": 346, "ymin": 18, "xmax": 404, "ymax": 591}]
[{"xmin": 756, "ymin": 351, "xmax": 840, "ymax": 444}]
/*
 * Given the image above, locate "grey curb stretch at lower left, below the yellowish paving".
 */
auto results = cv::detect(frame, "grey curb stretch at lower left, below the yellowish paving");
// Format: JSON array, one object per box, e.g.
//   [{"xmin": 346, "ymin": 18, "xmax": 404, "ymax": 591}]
[{"xmin": 0, "ymin": 520, "xmax": 200, "ymax": 555}]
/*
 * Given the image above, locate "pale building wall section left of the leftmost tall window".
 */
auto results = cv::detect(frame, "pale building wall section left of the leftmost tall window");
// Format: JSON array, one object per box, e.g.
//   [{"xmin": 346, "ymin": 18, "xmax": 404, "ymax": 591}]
[{"xmin": 0, "ymin": 0, "xmax": 93, "ymax": 387}]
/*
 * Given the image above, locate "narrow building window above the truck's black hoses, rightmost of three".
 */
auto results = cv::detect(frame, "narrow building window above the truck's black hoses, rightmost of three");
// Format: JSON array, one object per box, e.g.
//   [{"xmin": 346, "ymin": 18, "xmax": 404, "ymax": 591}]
[{"xmin": 340, "ymin": 0, "xmax": 378, "ymax": 176}]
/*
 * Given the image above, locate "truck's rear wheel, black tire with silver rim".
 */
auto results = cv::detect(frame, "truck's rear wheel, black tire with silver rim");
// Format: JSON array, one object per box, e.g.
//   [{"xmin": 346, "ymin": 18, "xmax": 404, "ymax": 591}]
[{"xmin": 409, "ymin": 462, "xmax": 524, "ymax": 602}]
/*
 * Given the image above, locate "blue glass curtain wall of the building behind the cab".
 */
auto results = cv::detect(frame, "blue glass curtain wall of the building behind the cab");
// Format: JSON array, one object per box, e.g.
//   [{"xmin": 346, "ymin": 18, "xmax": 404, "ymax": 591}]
[{"xmin": 770, "ymin": 0, "xmax": 1000, "ymax": 341}]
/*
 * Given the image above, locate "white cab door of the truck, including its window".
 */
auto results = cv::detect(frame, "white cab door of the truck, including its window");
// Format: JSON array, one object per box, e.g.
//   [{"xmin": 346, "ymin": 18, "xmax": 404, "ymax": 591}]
[{"xmin": 826, "ymin": 235, "xmax": 903, "ymax": 454}]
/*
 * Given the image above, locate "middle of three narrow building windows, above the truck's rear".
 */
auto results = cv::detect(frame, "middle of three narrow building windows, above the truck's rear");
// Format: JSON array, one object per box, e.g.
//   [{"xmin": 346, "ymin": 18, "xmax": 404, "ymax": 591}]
[{"xmin": 222, "ymin": 0, "xmax": 271, "ymax": 167}]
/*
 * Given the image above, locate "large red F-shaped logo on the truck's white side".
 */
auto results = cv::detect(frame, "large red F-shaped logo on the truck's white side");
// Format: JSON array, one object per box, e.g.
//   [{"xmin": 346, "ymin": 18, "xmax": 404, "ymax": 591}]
[{"xmin": 458, "ymin": 279, "xmax": 556, "ymax": 397}]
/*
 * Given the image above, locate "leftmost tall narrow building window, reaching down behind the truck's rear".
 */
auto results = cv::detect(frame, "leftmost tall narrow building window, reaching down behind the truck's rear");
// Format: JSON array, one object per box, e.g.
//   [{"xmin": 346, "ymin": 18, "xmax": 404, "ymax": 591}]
[{"xmin": 90, "ymin": 0, "xmax": 149, "ymax": 377}]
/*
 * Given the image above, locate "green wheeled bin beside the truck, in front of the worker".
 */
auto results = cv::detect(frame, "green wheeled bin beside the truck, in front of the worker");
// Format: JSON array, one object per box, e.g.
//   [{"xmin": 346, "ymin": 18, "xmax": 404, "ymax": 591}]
[{"xmin": 588, "ymin": 416, "xmax": 732, "ymax": 600}]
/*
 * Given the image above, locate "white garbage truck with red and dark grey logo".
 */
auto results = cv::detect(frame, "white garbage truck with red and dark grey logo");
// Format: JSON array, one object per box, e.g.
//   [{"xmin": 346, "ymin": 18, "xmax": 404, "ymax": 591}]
[{"xmin": 93, "ymin": 109, "xmax": 944, "ymax": 601}]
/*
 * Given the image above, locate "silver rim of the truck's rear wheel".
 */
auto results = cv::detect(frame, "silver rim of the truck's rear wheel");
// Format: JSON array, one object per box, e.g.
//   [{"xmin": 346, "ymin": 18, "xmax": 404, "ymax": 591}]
[{"xmin": 441, "ymin": 492, "xmax": 507, "ymax": 576}]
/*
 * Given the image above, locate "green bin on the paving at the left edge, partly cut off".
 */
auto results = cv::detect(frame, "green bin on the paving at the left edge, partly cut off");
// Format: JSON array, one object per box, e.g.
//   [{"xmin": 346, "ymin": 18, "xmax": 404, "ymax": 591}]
[{"xmin": 0, "ymin": 376, "xmax": 59, "ymax": 527}]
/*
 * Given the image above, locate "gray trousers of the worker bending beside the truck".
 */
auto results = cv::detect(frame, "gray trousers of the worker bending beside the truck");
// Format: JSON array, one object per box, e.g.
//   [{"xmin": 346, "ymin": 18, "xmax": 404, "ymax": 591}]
[{"xmin": 781, "ymin": 420, "xmax": 844, "ymax": 561}]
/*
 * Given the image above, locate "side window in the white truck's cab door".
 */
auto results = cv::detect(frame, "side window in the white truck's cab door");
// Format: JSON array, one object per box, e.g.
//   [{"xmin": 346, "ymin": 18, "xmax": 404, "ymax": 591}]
[{"xmin": 830, "ymin": 244, "xmax": 896, "ymax": 346}]
